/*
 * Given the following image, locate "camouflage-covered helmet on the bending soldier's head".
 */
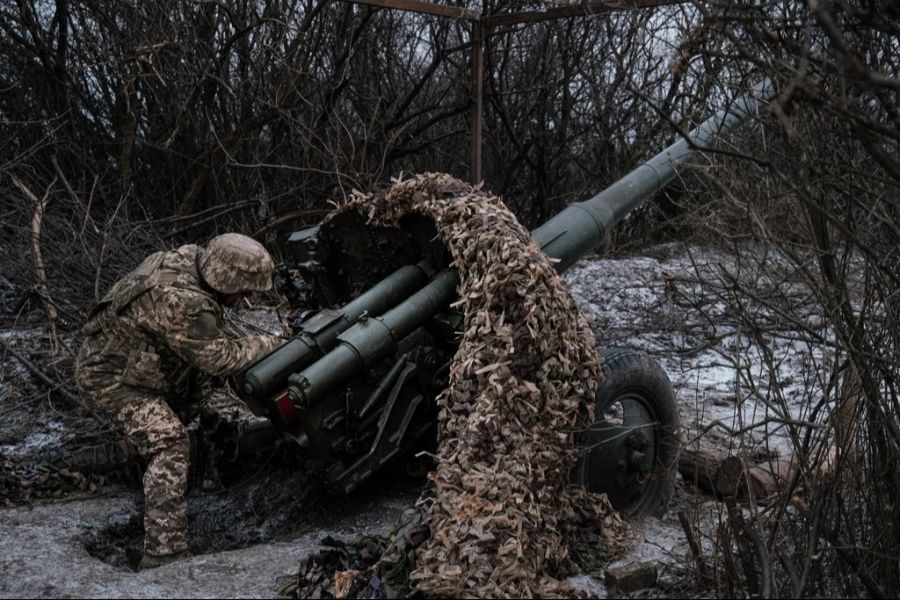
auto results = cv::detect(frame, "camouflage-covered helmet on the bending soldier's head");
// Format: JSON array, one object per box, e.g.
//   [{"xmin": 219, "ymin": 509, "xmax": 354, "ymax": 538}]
[{"xmin": 197, "ymin": 233, "xmax": 275, "ymax": 294}]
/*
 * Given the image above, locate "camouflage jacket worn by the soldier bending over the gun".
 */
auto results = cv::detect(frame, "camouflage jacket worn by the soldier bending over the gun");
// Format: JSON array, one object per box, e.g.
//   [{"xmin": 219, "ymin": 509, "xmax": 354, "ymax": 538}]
[{"xmin": 77, "ymin": 245, "xmax": 281, "ymax": 399}]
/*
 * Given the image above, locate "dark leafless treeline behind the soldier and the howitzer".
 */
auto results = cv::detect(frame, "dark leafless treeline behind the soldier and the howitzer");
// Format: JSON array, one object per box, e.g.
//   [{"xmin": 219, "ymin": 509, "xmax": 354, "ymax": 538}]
[{"xmin": 0, "ymin": 0, "xmax": 689, "ymax": 235}]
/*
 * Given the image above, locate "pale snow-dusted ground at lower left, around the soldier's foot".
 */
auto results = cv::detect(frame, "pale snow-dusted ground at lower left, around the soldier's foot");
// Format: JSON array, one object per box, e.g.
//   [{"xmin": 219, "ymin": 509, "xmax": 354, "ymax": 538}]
[{"xmin": 0, "ymin": 494, "xmax": 408, "ymax": 598}]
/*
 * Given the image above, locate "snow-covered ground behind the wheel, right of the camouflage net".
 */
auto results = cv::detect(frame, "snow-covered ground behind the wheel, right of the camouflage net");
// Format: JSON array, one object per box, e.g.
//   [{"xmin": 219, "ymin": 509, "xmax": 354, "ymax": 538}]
[{"xmin": 565, "ymin": 241, "xmax": 829, "ymax": 456}]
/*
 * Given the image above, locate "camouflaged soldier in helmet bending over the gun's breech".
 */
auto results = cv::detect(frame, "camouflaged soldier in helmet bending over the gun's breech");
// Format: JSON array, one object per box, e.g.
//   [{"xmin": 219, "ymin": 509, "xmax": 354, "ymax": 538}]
[{"xmin": 77, "ymin": 233, "xmax": 280, "ymax": 568}]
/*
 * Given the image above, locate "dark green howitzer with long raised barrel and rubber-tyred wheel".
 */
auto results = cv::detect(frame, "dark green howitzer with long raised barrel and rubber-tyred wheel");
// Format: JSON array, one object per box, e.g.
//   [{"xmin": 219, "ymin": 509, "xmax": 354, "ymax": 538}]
[{"xmin": 238, "ymin": 82, "xmax": 771, "ymax": 515}]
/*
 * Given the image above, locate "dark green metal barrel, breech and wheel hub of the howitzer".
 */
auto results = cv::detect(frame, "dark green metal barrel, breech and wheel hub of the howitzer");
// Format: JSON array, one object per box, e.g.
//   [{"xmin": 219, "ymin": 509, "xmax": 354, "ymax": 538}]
[{"xmin": 232, "ymin": 82, "xmax": 772, "ymax": 492}]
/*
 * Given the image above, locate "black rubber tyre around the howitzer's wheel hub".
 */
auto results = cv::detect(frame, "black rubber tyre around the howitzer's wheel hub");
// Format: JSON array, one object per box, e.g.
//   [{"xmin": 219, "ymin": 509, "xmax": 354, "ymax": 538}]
[{"xmin": 575, "ymin": 348, "xmax": 681, "ymax": 517}]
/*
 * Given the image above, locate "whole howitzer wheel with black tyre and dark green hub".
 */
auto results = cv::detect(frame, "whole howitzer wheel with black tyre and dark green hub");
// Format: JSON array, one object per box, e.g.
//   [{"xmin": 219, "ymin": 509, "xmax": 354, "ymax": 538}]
[{"xmin": 575, "ymin": 348, "xmax": 680, "ymax": 517}]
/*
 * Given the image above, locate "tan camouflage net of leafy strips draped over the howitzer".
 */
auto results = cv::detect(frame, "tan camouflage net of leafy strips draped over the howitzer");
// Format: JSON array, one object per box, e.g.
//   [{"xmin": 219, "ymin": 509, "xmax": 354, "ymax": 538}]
[{"xmin": 322, "ymin": 174, "xmax": 625, "ymax": 598}]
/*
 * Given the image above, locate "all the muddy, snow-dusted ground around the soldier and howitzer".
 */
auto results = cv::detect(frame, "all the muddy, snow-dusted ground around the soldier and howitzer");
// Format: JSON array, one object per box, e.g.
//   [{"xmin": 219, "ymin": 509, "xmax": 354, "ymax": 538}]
[{"xmin": 0, "ymin": 245, "xmax": 820, "ymax": 598}]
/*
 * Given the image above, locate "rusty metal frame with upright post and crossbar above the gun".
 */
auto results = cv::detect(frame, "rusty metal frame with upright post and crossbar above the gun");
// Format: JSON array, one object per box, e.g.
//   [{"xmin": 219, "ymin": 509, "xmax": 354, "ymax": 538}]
[{"xmin": 341, "ymin": 0, "xmax": 690, "ymax": 183}]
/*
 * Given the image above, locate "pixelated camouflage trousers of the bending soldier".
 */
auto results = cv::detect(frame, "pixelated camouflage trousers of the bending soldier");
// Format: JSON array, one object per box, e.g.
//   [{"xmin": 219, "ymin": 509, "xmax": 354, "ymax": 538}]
[{"xmin": 79, "ymin": 377, "xmax": 190, "ymax": 556}]
